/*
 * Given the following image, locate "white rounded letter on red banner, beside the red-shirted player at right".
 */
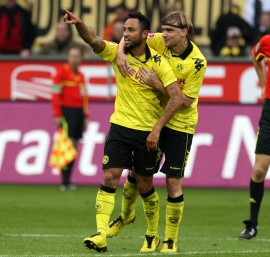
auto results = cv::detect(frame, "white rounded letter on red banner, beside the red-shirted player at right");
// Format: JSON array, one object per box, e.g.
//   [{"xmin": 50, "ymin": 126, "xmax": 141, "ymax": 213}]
[{"xmin": 239, "ymin": 67, "xmax": 261, "ymax": 103}]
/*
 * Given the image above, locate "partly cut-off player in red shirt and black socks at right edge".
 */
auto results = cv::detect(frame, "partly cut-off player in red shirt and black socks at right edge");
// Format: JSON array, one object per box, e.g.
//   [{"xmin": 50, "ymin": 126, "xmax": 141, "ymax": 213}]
[{"xmin": 239, "ymin": 34, "xmax": 270, "ymax": 239}]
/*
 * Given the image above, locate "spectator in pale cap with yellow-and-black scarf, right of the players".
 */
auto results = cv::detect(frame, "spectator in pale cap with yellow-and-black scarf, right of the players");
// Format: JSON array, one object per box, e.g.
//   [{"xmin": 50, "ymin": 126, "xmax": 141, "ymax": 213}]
[{"xmin": 219, "ymin": 27, "xmax": 247, "ymax": 57}]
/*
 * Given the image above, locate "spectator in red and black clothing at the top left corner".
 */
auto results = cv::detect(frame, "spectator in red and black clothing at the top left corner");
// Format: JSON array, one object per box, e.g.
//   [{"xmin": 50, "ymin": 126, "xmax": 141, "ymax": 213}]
[{"xmin": 0, "ymin": 0, "xmax": 36, "ymax": 57}]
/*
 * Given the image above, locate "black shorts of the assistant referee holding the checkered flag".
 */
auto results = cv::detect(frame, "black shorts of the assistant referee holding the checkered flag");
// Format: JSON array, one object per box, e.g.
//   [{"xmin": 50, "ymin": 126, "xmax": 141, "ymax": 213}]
[{"xmin": 62, "ymin": 107, "xmax": 84, "ymax": 140}]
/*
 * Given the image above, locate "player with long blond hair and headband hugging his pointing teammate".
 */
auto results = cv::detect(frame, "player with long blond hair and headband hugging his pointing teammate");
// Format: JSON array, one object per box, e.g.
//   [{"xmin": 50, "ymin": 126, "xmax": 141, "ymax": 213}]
[{"xmin": 107, "ymin": 12, "xmax": 207, "ymax": 253}]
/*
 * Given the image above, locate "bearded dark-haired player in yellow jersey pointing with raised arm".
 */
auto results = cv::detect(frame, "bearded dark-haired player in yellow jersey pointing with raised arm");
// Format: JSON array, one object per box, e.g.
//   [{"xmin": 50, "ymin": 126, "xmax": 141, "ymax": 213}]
[{"xmin": 64, "ymin": 10, "xmax": 186, "ymax": 252}]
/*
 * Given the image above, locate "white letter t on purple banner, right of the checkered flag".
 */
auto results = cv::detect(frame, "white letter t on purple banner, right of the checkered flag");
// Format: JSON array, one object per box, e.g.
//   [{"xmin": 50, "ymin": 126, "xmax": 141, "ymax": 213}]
[{"xmin": 79, "ymin": 121, "xmax": 106, "ymax": 176}]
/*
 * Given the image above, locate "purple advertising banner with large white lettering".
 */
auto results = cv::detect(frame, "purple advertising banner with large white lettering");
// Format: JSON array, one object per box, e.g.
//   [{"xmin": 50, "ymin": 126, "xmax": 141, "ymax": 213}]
[{"xmin": 0, "ymin": 102, "xmax": 270, "ymax": 188}]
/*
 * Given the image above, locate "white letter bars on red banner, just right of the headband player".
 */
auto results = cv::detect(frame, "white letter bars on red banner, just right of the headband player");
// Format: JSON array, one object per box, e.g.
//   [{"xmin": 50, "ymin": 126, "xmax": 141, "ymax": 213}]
[{"xmin": 199, "ymin": 65, "xmax": 226, "ymax": 98}]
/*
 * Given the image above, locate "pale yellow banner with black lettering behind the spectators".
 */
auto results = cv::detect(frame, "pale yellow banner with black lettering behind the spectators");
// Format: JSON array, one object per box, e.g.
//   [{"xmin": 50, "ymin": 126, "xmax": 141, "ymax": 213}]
[{"xmin": 0, "ymin": 0, "xmax": 245, "ymax": 46}]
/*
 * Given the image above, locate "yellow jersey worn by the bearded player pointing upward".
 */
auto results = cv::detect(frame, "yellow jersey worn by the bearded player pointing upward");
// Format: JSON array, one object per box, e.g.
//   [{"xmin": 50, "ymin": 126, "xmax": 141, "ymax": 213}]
[{"xmin": 98, "ymin": 41, "xmax": 177, "ymax": 131}]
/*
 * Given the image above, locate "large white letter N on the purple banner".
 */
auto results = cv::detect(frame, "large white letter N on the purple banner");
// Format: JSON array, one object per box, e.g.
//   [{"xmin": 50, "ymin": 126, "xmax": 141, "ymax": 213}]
[{"xmin": 221, "ymin": 115, "xmax": 256, "ymax": 179}]
